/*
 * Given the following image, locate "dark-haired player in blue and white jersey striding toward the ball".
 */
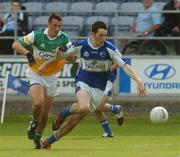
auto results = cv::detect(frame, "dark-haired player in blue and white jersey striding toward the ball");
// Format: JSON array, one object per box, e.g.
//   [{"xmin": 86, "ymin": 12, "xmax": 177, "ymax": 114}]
[{"xmin": 39, "ymin": 21, "xmax": 147, "ymax": 149}]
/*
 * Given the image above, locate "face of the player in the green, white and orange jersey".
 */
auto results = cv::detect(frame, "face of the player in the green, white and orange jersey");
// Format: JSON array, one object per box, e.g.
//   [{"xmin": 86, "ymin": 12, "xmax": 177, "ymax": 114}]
[{"xmin": 48, "ymin": 19, "xmax": 63, "ymax": 38}]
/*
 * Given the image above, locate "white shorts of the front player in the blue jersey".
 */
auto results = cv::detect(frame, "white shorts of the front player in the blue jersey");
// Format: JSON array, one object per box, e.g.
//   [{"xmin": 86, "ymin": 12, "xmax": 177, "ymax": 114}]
[{"xmin": 75, "ymin": 81, "xmax": 105, "ymax": 112}]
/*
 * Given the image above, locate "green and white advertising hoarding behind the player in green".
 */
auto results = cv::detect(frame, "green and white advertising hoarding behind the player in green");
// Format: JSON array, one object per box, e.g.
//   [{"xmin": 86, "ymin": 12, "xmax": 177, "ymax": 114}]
[{"xmin": 0, "ymin": 58, "xmax": 77, "ymax": 94}]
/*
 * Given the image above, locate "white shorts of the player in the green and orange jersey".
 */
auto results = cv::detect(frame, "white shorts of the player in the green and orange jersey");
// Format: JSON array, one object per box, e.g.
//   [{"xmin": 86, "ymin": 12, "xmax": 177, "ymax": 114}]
[{"xmin": 26, "ymin": 68, "xmax": 58, "ymax": 97}]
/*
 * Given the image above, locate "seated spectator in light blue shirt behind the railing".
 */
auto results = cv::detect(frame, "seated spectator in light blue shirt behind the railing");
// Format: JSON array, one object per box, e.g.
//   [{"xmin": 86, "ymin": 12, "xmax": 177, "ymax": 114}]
[{"xmin": 122, "ymin": 0, "xmax": 161, "ymax": 54}]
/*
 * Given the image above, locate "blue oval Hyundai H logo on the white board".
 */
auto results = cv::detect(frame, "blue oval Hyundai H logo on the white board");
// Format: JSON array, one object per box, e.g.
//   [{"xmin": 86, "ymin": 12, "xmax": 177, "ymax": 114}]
[{"xmin": 145, "ymin": 64, "xmax": 176, "ymax": 80}]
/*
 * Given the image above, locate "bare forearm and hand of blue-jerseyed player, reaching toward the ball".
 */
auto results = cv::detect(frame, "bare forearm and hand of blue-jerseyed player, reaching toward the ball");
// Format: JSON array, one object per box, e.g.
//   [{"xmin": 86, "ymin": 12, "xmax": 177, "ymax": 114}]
[{"xmin": 123, "ymin": 64, "xmax": 147, "ymax": 96}]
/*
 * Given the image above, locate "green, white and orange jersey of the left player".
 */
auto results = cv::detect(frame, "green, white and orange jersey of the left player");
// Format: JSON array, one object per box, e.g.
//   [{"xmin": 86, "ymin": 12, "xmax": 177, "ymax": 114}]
[{"xmin": 17, "ymin": 28, "xmax": 71, "ymax": 75}]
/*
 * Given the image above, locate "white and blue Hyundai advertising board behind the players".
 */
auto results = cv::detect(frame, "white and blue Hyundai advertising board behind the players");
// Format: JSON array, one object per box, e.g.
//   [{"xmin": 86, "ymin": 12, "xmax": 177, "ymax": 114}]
[{"xmin": 119, "ymin": 59, "xmax": 180, "ymax": 94}]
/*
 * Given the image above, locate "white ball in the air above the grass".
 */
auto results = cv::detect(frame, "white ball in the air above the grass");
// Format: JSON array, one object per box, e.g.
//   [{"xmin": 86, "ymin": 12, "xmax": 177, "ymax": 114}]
[{"xmin": 150, "ymin": 106, "xmax": 168, "ymax": 124}]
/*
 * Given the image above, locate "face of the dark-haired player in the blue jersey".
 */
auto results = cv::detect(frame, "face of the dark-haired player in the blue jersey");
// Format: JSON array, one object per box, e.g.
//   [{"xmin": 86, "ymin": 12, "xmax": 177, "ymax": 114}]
[{"xmin": 92, "ymin": 28, "xmax": 107, "ymax": 46}]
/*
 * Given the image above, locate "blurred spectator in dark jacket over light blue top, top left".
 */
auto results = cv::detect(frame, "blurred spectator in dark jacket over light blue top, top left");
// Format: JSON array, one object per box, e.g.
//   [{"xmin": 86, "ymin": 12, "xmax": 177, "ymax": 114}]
[{"xmin": 0, "ymin": 0, "xmax": 28, "ymax": 54}]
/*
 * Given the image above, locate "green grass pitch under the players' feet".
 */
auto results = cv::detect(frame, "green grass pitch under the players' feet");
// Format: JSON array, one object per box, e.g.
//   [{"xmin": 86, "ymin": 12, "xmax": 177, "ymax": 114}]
[{"xmin": 0, "ymin": 115, "xmax": 180, "ymax": 157}]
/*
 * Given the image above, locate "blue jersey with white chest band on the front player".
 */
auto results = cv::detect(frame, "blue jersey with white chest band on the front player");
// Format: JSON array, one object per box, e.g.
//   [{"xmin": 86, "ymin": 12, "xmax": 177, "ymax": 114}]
[{"xmin": 70, "ymin": 39, "xmax": 125, "ymax": 90}]
